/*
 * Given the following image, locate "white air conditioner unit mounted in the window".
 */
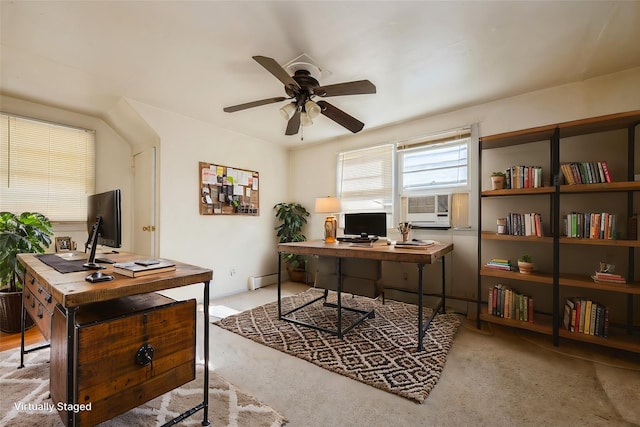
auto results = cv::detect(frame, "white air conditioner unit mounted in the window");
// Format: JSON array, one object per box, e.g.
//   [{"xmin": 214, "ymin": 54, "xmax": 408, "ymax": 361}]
[{"xmin": 405, "ymin": 194, "xmax": 451, "ymax": 228}]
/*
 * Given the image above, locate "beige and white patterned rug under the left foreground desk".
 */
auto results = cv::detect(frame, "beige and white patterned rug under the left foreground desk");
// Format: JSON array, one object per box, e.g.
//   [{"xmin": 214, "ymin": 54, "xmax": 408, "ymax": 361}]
[{"xmin": 0, "ymin": 350, "xmax": 286, "ymax": 427}]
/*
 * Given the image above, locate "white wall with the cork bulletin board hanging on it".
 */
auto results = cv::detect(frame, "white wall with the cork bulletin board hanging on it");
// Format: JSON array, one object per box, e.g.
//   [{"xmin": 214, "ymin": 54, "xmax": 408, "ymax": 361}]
[{"xmin": 129, "ymin": 100, "xmax": 288, "ymax": 299}]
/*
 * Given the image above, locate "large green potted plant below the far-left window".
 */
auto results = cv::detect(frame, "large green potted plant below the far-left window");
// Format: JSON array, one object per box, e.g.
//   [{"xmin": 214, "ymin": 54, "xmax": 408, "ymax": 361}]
[{"xmin": 0, "ymin": 212, "xmax": 53, "ymax": 333}]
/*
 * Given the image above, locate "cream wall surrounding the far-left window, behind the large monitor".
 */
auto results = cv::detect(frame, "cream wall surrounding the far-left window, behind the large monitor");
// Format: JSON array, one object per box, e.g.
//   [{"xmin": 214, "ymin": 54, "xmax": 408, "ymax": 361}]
[{"xmin": 1, "ymin": 95, "xmax": 133, "ymax": 251}]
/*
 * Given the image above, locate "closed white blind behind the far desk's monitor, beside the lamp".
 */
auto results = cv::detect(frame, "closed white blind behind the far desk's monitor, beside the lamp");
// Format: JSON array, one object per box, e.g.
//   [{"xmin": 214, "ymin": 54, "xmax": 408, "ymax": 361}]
[{"xmin": 338, "ymin": 144, "xmax": 394, "ymax": 215}]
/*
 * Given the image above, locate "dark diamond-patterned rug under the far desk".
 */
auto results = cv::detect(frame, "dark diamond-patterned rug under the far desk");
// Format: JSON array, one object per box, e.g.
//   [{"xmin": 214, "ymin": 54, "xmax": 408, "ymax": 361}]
[{"xmin": 214, "ymin": 288, "xmax": 461, "ymax": 403}]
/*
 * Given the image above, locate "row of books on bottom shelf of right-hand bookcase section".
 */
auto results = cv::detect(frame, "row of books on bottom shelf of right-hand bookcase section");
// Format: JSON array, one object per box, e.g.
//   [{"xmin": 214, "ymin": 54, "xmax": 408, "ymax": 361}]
[{"xmin": 563, "ymin": 297, "xmax": 609, "ymax": 338}]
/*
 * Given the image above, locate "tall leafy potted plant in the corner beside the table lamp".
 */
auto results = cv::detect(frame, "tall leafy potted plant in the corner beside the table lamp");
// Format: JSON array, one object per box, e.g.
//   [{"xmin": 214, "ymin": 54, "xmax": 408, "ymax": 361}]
[{"xmin": 273, "ymin": 203, "xmax": 310, "ymax": 283}]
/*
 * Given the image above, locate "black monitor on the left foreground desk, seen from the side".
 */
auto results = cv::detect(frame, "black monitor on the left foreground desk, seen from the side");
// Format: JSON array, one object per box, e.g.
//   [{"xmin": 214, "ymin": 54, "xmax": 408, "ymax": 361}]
[{"xmin": 84, "ymin": 190, "xmax": 122, "ymax": 269}]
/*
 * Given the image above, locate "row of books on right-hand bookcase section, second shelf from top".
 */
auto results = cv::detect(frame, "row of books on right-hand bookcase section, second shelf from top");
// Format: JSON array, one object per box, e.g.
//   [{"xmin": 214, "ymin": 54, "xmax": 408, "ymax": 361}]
[{"xmin": 562, "ymin": 212, "xmax": 618, "ymax": 240}]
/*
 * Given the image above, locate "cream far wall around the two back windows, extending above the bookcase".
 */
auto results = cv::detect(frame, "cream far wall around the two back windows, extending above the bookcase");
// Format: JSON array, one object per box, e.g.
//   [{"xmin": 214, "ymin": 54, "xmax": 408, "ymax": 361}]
[{"xmin": 289, "ymin": 68, "xmax": 640, "ymax": 309}]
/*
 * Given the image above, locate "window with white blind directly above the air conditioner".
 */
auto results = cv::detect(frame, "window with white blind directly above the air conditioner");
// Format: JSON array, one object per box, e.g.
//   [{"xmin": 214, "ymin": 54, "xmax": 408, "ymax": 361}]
[{"xmin": 397, "ymin": 128, "xmax": 471, "ymax": 195}]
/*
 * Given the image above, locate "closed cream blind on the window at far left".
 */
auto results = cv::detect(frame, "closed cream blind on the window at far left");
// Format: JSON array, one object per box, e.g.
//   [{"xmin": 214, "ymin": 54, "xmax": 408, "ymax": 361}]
[{"xmin": 0, "ymin": 114, "xmax": 95, "ymax": 222}]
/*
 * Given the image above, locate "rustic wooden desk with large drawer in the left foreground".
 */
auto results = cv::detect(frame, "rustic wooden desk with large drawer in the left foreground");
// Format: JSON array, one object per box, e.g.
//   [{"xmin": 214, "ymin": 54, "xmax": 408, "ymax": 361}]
[{"xmin": 18, "ymin": 253, "xmax": 213, "ymax": 427}]
